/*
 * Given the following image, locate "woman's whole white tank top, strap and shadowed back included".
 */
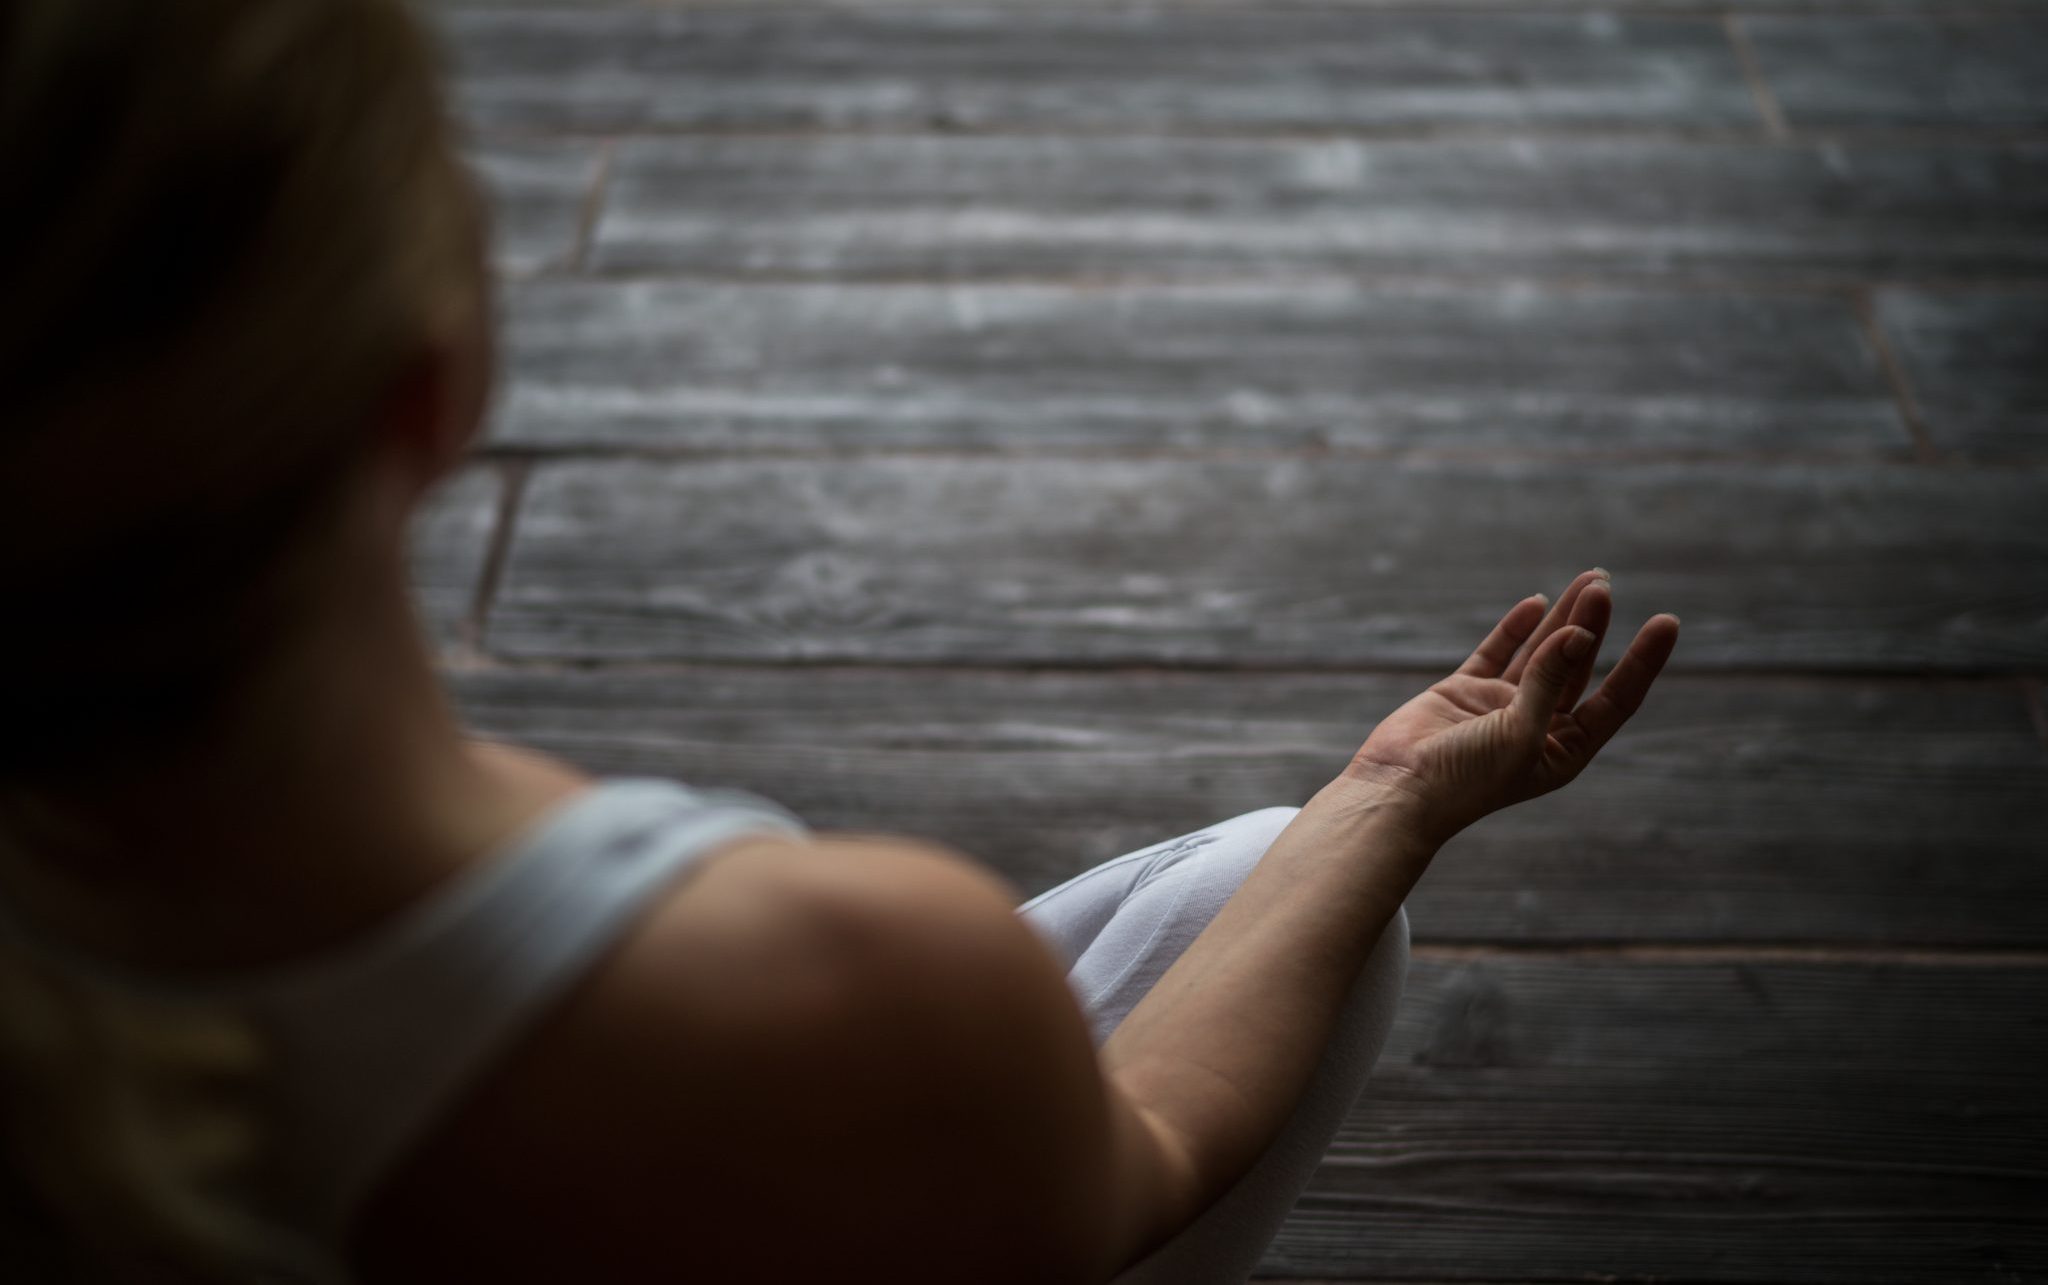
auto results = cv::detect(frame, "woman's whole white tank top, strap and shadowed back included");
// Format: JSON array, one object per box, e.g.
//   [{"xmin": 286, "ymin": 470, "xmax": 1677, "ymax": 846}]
[{"xmin": 0, "ymin": 777, "xmax": 809, "ymax": 1283}]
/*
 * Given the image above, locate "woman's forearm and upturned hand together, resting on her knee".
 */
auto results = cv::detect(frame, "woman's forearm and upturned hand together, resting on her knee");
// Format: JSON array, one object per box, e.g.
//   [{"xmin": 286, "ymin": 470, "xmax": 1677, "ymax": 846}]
[{"xmin": 1102, "ymin": 572, "xmax": 1677, "ymax": 1258}]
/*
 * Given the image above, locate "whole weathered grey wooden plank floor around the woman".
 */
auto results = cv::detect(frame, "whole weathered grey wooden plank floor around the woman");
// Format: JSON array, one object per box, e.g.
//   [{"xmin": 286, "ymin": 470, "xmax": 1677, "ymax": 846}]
[{"xmin": 418, "ymin": 0, "xmax": 2048, "ymax": 1283}]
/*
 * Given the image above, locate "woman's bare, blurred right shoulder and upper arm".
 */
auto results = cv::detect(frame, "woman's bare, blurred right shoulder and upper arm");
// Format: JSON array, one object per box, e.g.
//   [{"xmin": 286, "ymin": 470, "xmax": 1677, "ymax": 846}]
[{"xmin": 356, "ymin": 834, "xmax": 1100, "ymax": 1283}]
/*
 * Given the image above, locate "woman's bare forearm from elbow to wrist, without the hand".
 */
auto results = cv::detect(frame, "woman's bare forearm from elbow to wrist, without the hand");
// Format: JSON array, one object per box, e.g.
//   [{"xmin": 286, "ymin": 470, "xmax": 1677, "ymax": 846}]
[{"xmin": 1100, "ymin": 779, "xmax": 1436, "ymax": 1234}]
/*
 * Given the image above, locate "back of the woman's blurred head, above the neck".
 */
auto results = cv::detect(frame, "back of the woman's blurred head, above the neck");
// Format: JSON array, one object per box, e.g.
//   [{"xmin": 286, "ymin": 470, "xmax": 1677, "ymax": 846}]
[{"xmin": 0, "ymin": 0, "xmax": 475, "ymax": 781}]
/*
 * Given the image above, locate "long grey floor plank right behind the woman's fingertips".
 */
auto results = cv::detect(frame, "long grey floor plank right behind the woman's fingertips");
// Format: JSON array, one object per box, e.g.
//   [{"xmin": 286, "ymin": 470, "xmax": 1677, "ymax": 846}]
[{"xmin": 487, "ymin": 457, "xmax": 2048, "ymax": 672}]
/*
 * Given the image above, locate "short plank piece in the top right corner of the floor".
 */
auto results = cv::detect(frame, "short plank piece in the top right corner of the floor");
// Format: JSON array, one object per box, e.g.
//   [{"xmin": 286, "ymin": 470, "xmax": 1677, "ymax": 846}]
[{"xmin": 1743, "ymin": 12, "xmax": 2048, "ymax": 129}]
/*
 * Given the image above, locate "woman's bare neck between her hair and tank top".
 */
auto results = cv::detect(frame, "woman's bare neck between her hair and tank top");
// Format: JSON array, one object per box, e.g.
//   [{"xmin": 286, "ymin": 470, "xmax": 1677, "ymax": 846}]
[{"xmin": 0, "ymin": 549, "xmax": 590, "ymax": 969}]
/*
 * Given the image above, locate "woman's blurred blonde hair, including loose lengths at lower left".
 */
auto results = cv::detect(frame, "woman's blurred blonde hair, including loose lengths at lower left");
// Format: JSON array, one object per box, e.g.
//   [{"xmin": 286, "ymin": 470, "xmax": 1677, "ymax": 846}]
[{"xmin": 0, "ymin": 0, "xmax": 481, "ymax": 1281}]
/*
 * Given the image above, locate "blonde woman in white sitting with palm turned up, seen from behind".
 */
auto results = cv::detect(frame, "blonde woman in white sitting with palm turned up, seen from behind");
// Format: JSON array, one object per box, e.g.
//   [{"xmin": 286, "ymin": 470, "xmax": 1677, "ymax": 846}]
[{"xmin": 0, "ymin": 0, "xmax": 1677, "ymax": 1285}]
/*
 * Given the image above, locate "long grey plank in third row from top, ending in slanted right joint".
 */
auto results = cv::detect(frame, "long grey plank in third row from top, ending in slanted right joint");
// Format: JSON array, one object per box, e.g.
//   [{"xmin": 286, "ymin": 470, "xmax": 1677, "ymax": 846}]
[{"xmin": 494, "ymin": 281, "xmax": 1909, "ymax": 455}]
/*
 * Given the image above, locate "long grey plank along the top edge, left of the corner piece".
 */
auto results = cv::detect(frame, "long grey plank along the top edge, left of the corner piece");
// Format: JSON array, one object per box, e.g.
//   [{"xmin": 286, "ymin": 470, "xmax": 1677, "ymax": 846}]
[{"xmin": 442, "ymin": 4, "xmax": 1757, "ymax": 131}]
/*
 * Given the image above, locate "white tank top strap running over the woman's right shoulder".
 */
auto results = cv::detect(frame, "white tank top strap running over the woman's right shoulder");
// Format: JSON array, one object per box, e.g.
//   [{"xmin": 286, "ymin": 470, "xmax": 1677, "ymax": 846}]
[{"xmin": 268, "ymin": 779, "xmax": 805, "ymax": 1246}]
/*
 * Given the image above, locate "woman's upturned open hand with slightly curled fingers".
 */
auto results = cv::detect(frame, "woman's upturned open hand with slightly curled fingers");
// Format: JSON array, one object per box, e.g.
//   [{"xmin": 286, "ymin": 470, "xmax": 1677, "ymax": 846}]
[{"xmin": 1337, "ymin": 568, "xmax": 1677, "ymax": 844}]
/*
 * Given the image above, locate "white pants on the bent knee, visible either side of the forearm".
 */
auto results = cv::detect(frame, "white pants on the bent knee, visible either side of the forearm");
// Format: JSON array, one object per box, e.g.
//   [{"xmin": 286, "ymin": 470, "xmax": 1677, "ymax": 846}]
[{"xmin": 1018, "ymin": 807, "xmax": 1409, "ymax": 1285}]
